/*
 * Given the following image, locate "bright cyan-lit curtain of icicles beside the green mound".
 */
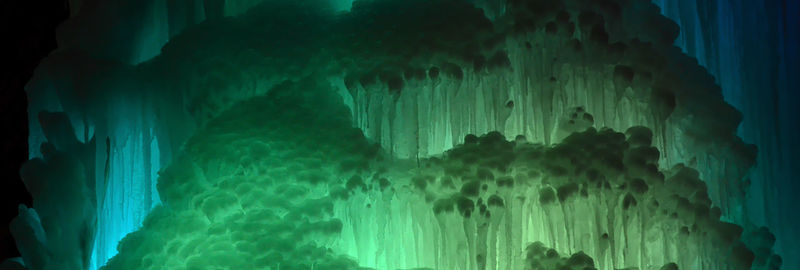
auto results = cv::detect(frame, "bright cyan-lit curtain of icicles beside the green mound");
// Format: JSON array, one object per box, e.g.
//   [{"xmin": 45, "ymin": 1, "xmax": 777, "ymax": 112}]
[{"xmin": 24, "ymin": 58, "xmax": 184, "ymax": 269}]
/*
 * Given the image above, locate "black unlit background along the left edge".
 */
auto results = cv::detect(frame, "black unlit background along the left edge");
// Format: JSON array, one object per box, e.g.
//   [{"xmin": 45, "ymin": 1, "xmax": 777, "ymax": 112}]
[{"xmin": 0, "ymin": 0, "xmax": 69, "ymax": 261}]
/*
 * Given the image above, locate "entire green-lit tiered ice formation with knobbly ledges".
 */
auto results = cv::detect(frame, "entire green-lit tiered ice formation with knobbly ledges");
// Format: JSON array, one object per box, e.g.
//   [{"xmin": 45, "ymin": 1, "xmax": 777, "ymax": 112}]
[{"xmin": 9, "ymin": 0, "xmax": 780, "ymax": 269}]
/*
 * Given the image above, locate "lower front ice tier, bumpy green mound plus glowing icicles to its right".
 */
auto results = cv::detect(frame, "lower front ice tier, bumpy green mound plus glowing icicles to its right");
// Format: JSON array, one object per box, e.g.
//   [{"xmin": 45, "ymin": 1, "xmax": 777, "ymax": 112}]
[{"xmin": 97, "ymin": 80, "xmax": 779, "ymax": 269}]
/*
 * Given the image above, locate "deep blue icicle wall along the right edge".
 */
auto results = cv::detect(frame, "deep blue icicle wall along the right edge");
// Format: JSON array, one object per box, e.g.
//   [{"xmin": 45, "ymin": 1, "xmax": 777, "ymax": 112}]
[{"xmin": 654, "ymin": 0, "xmax": 800, "ymax": 269}]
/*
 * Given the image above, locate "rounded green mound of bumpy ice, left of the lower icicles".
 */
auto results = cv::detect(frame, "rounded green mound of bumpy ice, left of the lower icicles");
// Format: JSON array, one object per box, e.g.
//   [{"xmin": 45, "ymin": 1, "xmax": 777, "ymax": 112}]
[{"xmin": 104, "ymin": 81, "xmax": 378, "ymax": 269}]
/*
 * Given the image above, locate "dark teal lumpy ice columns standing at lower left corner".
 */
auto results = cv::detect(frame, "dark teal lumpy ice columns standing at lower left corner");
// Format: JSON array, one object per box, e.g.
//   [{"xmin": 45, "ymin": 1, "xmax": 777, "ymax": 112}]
[{"xmin": 10, "ymin": 112, "xmax": 97, "ymax": 270}]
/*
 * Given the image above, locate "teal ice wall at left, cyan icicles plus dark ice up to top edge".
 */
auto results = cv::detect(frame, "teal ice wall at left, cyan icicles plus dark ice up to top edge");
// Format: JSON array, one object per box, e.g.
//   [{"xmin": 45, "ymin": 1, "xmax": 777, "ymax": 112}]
[{"xmin": 21, "ymin": 0, "xmax": 241, "ymax": 269}]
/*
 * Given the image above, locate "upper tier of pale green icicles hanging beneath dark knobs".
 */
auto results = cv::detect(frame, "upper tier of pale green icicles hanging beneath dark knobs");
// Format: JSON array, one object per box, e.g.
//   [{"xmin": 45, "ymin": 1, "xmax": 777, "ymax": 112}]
[{"xmin": 344, "ymin": 1, "xmax": 754, "ymax": 238}]
